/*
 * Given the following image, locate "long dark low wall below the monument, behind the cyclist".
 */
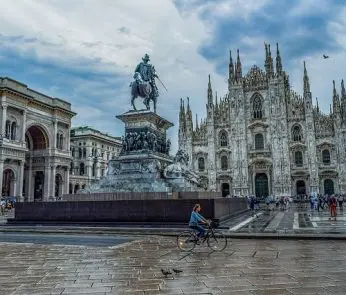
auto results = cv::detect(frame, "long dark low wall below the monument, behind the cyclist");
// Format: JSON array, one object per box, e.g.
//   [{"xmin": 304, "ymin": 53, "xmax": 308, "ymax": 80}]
[{"xmin": 14, "ymin": 198, "xmax": 246, "ymax": 223}]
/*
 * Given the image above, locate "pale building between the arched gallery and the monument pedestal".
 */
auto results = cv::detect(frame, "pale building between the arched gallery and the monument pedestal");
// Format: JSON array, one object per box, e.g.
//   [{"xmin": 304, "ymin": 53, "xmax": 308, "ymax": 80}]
[{"xmin": 69, "ymin": 127, "xmax": 122, "ymax": 194}]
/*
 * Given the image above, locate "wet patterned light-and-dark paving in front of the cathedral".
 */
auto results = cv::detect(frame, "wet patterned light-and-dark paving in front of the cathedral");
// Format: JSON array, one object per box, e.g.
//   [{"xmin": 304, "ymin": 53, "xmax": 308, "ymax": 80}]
[{"xmin": 222, "ymin": 203, "xmax": 346, "ymax": 234}]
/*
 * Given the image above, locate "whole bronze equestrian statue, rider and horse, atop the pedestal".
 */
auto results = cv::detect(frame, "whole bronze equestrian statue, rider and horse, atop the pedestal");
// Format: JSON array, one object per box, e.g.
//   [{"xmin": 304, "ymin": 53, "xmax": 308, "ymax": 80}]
[{"xmin": 130, "ymin": 54, "xmax": 164, "ymax": 113}]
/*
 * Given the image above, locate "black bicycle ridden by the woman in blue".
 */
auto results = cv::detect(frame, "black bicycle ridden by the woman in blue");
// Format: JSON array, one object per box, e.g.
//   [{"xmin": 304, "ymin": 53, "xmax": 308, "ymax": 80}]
[{"xmin": 177, "ymin": 223, "xmax": 227, "ymax": 251}]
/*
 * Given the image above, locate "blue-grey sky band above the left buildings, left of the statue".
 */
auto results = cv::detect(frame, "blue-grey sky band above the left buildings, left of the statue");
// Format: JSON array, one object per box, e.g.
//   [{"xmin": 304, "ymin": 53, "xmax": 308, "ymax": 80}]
[{"xmin": 0, "ymin": 48, "xmax": 129, "ymax": 135}]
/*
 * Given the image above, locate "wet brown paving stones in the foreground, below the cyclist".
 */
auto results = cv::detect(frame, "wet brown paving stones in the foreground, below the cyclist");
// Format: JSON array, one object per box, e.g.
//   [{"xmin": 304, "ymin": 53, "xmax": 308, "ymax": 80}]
[{"xmin": 0, "ymin": 236, "xmax": 346, "ymax": 295}]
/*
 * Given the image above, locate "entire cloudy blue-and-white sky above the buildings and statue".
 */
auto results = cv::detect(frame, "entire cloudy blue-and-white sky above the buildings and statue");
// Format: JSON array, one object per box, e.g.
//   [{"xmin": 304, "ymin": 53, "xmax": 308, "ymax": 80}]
[{"xmin": 0, "ymin": 0, "xmax": 346, "ymax": 153}]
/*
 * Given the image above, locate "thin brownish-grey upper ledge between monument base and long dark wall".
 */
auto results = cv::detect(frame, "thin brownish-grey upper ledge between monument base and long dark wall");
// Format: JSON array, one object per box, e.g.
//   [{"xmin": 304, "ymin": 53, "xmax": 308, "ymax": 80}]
[{"xmin": 62, "ymin": 192, "xmax": 221, "ymax": 201}]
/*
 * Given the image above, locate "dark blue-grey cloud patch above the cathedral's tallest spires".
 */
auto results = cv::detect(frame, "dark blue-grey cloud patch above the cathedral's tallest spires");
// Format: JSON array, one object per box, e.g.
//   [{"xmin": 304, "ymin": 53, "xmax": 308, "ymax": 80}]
[{"xmin": 175, "ymin": 0, "xmax": 346, "ymax": 75}]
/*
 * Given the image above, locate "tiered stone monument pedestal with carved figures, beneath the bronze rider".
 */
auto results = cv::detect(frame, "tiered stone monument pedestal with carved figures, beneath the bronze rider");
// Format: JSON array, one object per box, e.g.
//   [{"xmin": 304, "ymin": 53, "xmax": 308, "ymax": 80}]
[{"xmin": 80, "ymin": 110, "xmax": 198, "ymax": 193}]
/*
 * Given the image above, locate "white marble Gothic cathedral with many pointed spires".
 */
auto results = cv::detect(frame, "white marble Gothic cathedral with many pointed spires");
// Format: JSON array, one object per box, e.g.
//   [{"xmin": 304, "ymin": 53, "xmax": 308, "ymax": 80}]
[{"xmin": 179, "ymin": 44, "xmax": 346, "ymax": 196}]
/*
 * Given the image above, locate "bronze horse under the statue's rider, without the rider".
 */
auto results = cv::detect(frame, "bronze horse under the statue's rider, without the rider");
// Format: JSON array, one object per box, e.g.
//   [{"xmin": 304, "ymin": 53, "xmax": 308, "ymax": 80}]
[{"xmin": 130, "ymin": 72, "xmax": 157, "ymax": 113}]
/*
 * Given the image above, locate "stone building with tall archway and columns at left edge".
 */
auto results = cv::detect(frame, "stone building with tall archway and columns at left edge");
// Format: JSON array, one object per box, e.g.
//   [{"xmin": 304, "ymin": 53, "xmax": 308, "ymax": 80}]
[{"xmin": 0, "ymin": 77, "xmax": 75, "ymax": 201}]
